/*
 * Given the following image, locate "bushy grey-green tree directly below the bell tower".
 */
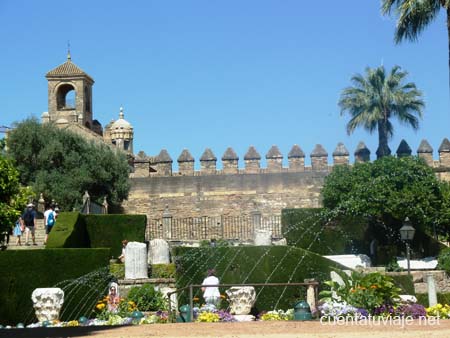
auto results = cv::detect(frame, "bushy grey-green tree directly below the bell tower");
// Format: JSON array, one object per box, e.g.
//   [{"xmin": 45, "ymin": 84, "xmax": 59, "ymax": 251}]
[{"xmin": 8, "ymin": 119, "xmax": 129, "ymax": 210}]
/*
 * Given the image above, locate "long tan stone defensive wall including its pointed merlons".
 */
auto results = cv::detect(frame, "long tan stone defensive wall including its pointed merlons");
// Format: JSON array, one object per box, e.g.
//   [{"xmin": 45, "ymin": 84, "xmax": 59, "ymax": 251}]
[{"xmin": 123, "ymin": 139, "xmax": 450, "ymax": 224}]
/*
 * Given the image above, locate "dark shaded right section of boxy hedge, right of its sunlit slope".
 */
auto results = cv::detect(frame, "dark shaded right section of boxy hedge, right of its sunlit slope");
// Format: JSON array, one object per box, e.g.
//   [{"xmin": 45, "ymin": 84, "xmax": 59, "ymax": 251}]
[{"xmin": 84, "ymin": 215, "xmax": 147, "ymax": 257}]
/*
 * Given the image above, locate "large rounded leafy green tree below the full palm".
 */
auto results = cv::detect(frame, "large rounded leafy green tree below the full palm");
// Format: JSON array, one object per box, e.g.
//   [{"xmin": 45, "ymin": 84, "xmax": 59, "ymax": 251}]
[{"xmin": 322, "ymin": 156, "xmax": 450, "ymax": 233}]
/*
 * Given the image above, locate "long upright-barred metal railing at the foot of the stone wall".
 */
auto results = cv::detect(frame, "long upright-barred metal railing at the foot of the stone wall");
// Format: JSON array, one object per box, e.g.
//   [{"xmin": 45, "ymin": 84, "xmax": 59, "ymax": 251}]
[{"xmin": 145, "ymin": 215, "xmax": 283, "ymax": 240}]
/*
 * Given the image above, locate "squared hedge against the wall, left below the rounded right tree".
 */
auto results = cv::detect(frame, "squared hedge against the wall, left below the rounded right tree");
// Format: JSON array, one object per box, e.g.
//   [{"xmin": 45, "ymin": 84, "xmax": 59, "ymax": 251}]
[{"xmin": 281, "ymin": 208, "xmax": 371, "ymax": 255}]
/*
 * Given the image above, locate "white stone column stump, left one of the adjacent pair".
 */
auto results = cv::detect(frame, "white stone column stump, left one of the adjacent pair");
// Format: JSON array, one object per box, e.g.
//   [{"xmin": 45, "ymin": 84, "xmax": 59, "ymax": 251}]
[{"xmin": 125, "ymin": 242, "xmax": 148, "ymax": 279}]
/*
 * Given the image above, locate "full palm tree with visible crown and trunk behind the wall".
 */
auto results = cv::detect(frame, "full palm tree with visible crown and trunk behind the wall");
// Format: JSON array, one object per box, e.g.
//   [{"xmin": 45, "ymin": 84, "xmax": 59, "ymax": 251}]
[{"xmin": 339, "ymin": 66, "xmax": 425, "ymax": 158}]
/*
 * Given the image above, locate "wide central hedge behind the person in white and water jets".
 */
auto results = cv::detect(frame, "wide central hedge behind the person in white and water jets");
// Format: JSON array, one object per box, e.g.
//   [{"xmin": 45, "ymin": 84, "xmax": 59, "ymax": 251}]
[{"xmin": 173, "ymin": 246, "xmax": 342, "ymax": 313}]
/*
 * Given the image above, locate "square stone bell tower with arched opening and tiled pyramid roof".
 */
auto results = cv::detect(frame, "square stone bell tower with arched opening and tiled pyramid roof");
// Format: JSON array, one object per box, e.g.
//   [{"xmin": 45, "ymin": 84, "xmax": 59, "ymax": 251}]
[{"xmin": 44, "ymin": 51, "xmax": 94, "ymax": 130}]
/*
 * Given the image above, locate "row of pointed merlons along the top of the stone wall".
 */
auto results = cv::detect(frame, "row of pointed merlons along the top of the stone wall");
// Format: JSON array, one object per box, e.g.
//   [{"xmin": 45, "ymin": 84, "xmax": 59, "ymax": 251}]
[{"xmin": 130, "ymin": 138, "xmax": 450, "ymax": 178}]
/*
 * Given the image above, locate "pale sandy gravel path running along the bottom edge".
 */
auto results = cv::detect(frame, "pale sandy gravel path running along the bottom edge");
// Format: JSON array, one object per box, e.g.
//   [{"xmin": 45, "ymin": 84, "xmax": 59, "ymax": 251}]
[{"xmin": 75, "ymin": 320, "xmax": 450, "ymax": 338}]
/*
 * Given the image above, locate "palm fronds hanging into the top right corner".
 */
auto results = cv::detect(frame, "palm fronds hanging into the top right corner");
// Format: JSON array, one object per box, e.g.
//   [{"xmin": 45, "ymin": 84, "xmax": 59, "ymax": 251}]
[{"xmin": 381, "ymin": 0, "xmax": 450, "ymax": 87}]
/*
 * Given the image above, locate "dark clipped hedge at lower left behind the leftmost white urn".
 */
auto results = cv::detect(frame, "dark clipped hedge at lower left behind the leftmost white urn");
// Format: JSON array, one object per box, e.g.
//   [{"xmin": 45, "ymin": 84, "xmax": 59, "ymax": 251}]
[{"xmin": 0, "ymin": 249, "xmax": 109, "ymax": 325}]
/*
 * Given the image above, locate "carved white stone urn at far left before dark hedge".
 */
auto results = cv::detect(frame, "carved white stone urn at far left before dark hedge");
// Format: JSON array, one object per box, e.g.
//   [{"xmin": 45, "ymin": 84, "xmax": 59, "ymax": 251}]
[{"xmin": 31, "ymin": 288, "xmax": 64, "ymax": 322}]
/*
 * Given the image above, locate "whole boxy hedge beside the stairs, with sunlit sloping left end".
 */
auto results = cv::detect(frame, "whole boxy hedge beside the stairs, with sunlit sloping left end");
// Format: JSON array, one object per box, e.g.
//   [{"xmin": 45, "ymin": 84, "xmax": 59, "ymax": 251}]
[{"xmin": 47, "ymin": 212, "xmax": 147, "ymax": 257}]
